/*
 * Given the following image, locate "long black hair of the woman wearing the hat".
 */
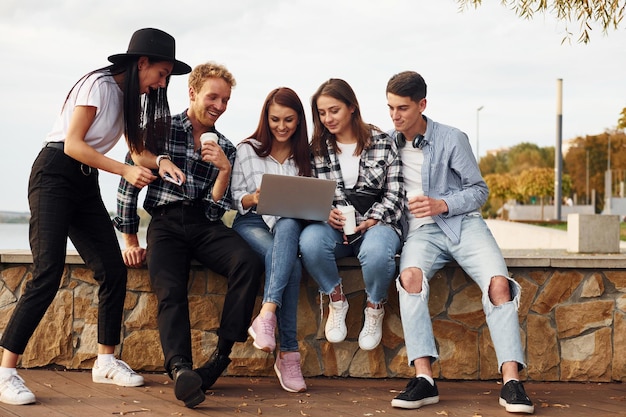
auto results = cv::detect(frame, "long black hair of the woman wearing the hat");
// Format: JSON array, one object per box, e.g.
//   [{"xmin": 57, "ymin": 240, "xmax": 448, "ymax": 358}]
[{"xmin": 63, "ymin": 57, "xmax": 172, "ymax": 154}]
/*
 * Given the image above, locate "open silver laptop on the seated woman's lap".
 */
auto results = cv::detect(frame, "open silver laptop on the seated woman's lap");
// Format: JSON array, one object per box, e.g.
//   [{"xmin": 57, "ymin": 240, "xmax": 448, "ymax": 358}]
[{"xmin": 256, "ymin": 174, "xmax": 337, "ymax": 221}]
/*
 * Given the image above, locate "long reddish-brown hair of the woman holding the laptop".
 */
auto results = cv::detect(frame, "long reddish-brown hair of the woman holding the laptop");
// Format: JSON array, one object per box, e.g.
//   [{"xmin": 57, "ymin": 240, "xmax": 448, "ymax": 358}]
[{"xmin": 244, "ymin": 87, "xmax": 311, "ymax": 177}]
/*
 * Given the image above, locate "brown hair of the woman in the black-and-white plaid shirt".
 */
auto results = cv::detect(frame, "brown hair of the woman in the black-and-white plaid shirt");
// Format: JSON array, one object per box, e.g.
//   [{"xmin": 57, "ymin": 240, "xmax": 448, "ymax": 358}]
[{"xmin": 311, "ymin": 78, "xmax": 373, "ymax": 156}]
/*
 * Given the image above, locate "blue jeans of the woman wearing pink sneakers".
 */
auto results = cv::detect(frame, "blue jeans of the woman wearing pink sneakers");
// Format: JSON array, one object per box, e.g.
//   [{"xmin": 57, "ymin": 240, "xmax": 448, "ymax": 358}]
[{"xmin": 233, "ymin": 212, "xmax": 302, "ymax": 352}]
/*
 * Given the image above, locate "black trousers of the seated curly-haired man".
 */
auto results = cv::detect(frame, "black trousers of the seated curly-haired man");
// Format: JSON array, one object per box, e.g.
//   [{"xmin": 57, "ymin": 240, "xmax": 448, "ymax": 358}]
[{"xmin": 147, "ymin": 203, "xmax": 264, "ymax": 370}]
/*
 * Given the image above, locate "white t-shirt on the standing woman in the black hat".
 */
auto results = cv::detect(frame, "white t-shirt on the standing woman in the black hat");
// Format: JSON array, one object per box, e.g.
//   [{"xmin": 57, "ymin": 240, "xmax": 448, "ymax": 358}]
[{"xmin": 46, "ymin": 73, "xmax": 124, "ymax": 154}]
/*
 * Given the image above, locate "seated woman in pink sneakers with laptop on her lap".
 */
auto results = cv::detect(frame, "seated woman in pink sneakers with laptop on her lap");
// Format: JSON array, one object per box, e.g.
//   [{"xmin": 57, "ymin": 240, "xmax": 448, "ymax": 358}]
[{"xmin": 232, "ymin": 87, "xmax": 311, "ymax": 392}]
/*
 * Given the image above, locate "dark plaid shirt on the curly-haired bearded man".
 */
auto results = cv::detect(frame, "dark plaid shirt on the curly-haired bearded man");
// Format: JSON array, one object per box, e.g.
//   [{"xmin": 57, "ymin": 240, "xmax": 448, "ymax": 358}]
[{"xmin": 113, "ymin": 110, "xmax": 236, "ymax": 234}]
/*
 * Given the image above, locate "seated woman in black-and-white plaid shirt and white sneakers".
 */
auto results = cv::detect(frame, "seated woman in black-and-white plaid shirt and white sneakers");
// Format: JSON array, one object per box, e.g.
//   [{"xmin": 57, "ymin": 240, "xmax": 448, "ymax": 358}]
[{"xmin": 300, "ymin": 78, "xmax": 404, "ymax": 350}]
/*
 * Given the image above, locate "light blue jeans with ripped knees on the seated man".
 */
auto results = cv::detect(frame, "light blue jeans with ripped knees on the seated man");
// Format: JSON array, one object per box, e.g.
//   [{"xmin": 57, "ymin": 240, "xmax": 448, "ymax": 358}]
[{"xmin": 396, "ymin": 214, "xmax": 525, "ymax": 370}]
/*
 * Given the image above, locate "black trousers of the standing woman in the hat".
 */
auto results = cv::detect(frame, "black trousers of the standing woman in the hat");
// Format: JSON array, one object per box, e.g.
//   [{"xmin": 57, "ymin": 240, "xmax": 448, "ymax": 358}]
[{"xmin": 0, "ymin": 147, "xmax": 127, "ymax": 354}]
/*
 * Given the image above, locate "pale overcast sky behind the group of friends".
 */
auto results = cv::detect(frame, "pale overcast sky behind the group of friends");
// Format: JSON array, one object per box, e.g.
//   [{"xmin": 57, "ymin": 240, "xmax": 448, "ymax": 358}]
[{"xmin": 0, "ymin": 0, "xmax": 626, "ymax": 211}]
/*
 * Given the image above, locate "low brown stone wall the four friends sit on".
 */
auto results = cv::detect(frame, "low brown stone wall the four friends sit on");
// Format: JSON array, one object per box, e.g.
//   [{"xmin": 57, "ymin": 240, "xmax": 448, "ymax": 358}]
[{"xmin": 0, "ymin": 253, "xmax": 626, "ymax": 382}]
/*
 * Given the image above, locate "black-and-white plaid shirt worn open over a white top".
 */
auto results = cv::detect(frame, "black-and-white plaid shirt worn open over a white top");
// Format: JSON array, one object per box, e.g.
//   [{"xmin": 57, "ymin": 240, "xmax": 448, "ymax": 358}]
[{"xmin": 312, "ymin": 129, "xmax": 404, "ymax": 235}]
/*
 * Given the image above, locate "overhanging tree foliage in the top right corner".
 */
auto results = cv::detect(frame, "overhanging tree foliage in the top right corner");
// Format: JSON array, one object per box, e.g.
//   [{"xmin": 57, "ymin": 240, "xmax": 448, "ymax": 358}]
[{"xmin": 457, "ymin": 0, "xmax": 626, "ymax": 43}]
